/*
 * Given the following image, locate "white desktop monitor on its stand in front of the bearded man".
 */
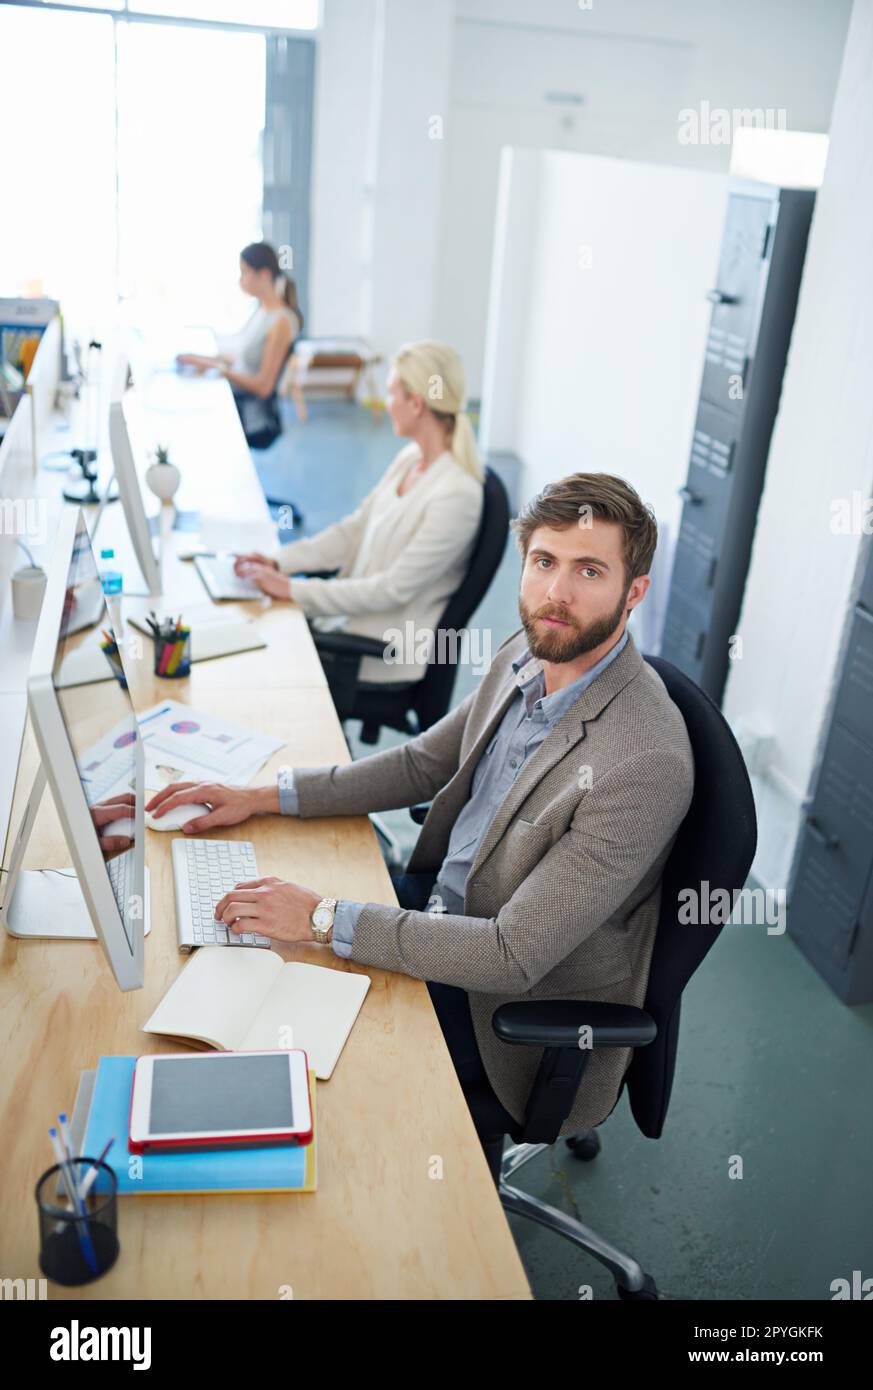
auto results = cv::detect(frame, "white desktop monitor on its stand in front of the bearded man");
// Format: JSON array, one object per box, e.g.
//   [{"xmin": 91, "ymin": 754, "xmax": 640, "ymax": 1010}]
[{"xmin": 0, "ymin": 507, "xmax": 149, "ymax": 990}]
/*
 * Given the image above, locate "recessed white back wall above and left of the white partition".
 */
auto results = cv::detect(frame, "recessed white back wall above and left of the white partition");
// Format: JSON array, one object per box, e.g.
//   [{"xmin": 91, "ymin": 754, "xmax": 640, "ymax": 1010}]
[{"xmin": 433, "ymin": 0, "xmax": 851, "ymax": 395}]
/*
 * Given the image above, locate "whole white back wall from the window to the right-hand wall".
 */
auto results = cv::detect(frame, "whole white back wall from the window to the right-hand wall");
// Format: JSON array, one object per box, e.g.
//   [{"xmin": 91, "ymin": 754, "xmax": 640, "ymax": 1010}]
[{"xmin": 307, "ymin": 0, "xmax": 851, "ymax": 396}]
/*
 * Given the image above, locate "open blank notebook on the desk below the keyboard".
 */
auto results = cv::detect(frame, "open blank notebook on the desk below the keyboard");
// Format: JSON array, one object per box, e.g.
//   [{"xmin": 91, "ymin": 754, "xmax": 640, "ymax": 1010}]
[{"xmin": 143, "ymin": 947, "xmax": 370, "ymax": 1081}]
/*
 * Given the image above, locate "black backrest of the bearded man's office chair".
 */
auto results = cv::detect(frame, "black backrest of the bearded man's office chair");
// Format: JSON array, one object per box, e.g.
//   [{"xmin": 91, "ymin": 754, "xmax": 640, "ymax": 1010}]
[{"xmin": 624, "ymin": 656, "xmax": 758, "ymax": 1138}]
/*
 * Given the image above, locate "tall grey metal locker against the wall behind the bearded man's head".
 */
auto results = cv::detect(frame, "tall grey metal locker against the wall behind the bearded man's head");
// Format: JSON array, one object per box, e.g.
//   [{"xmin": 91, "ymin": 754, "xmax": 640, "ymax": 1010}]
[{"xmin": 660, "ymin": 179, "xmax": 815, "ymax": 702}]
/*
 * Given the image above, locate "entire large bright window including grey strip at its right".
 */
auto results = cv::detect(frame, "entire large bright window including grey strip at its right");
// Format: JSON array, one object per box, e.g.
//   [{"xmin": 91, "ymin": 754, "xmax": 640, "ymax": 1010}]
[{"xmin": 0, "ymin": 4, "xmax": 313, "ymax": 338}]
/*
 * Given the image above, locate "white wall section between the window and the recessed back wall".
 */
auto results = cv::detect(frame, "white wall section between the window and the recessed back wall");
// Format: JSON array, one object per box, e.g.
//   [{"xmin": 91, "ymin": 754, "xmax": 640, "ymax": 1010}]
[{"xmin": 307, "ymin": 0, "xmax": 455, "ymax": 369}]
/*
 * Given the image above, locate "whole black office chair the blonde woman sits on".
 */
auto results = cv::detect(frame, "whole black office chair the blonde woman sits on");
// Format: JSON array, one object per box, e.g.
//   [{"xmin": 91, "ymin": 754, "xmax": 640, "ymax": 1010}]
[{"xmin": 313, "ymin": 468, "xmax": 509, "ymax": 744}]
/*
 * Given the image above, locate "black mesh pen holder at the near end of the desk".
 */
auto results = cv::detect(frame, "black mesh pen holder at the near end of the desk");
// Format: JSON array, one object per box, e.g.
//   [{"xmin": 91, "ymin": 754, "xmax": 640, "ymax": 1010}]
[{"xmin": 36, "ymin": 1158, "xmax": 118, "ymax": 1284}]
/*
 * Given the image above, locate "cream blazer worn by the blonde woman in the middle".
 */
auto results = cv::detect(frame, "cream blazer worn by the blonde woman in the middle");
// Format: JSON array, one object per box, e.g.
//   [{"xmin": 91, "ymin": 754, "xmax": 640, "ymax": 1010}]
[{"xmin": 277, "ymin": 445, "xmax": 482, "ymax": 682}]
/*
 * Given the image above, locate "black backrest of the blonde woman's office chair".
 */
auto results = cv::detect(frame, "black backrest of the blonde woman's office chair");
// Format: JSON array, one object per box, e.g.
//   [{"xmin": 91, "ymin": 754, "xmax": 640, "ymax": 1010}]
[{"xmin": 410, "ymin": 468, "xmax": 509, "ymax": 730}]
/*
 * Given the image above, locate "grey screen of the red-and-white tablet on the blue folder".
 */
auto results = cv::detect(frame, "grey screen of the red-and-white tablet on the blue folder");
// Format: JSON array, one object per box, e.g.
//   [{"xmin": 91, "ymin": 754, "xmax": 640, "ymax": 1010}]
[{"xmin": 149, "ymin": 1052, "xmax": 293, "ymax": 1134}]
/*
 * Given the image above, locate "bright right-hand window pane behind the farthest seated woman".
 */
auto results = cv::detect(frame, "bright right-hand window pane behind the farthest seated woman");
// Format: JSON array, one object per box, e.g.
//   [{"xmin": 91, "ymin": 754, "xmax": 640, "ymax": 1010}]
[{"xmin": 117, "ymin": 22, "xmax": 266, "ymax": 331}]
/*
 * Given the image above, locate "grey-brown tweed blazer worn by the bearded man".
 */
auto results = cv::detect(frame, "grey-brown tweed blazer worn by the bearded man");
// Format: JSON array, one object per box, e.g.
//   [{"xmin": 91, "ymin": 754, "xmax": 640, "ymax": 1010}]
[{"xmin": 295, "ymin": 632, "xmax": 694, "ymax": 1134}]
